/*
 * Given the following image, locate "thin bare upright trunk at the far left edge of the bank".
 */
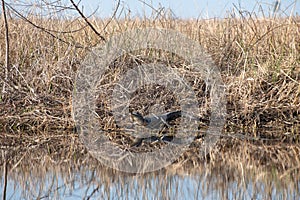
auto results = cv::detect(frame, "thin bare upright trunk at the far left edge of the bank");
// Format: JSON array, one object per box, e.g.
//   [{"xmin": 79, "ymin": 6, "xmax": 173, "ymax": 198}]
[{"xmin": 2, "ymin": 0, "xmax": 9, "ymax": 96}]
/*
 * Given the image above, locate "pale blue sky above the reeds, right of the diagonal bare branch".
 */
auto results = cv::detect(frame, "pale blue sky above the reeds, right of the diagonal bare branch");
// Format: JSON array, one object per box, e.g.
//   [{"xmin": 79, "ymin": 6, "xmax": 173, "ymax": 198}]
[{"xmin": 81, "ymin": 0, "xmax": 300, "ymax": 19}]
